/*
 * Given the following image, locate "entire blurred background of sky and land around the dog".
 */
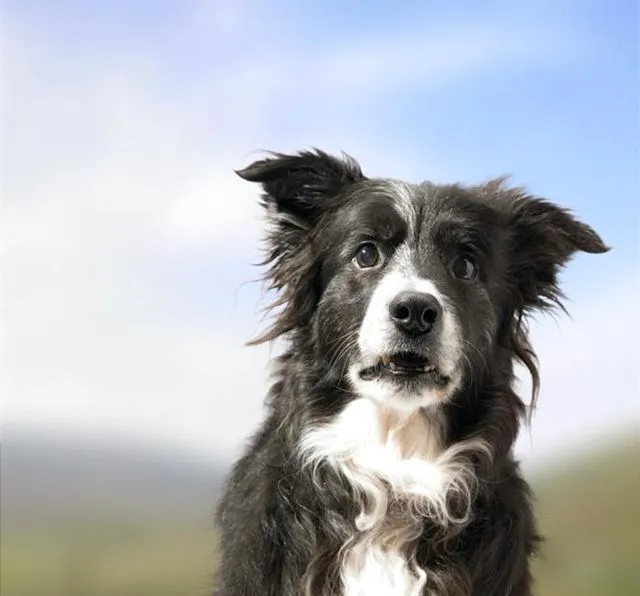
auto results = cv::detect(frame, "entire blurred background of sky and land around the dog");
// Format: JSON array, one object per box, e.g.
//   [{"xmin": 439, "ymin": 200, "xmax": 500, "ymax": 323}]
[{"xmin": 0, "ymin": 0, "xmax": 640, "ymax": 596}]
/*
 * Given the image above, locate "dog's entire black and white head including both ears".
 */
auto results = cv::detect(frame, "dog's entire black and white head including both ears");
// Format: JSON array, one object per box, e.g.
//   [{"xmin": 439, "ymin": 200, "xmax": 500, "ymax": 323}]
[{"xmin": 238, "ymin": 151, "xmax": 607, "ymax": 410}]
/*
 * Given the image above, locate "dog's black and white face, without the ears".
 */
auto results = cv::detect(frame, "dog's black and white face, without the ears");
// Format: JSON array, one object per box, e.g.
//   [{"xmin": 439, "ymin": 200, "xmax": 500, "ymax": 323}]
[{"xmin": 317, "ymin": 181, "xmax": 505, "ymax": 409}]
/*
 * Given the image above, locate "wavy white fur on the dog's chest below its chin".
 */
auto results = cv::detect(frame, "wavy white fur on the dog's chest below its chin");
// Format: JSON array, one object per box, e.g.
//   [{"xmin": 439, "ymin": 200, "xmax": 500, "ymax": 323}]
[{"xmin": 301, "ymin": 398, "xmax": 483, "ymax": 596}]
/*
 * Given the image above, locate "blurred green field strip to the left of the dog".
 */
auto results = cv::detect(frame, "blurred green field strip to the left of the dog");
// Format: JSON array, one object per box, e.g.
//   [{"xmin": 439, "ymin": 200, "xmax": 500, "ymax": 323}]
[{"xmin": 0, "ymin": 520, "xmax": 214, "ymax": 596}]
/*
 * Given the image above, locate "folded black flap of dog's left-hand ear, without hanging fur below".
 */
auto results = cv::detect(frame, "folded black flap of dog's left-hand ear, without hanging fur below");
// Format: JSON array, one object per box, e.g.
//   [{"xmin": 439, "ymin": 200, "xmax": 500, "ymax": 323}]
[{"xmin": 236, "ymin": 149, "xmax": 364, "ymax": 229}]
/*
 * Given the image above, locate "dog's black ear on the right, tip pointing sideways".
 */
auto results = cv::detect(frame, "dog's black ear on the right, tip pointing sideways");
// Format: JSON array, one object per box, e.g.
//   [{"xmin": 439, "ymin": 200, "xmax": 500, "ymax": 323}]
[{"xmin": 509, "ymin": 192, "xmax": 609, "ymax": 309}]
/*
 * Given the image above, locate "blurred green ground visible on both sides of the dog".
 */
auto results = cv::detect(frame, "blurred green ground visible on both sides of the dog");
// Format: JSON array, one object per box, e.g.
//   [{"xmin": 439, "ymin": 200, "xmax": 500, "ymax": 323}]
[{"xmin": 0, "ymin": 436, "xmax": 640, "ymax": 596}]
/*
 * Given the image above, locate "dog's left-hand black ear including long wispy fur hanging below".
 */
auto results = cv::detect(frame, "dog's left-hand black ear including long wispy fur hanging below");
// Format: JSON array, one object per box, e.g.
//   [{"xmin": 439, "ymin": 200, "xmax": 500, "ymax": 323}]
[{"xmin": 237, "ymin": 149, "xmax": 365, "ymax": 344}]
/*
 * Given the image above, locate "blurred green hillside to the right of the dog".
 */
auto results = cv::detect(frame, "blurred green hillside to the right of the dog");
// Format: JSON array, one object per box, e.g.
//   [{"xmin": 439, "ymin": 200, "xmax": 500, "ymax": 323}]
[{"xmin": 535, "ymin": 441, "xmax": 640, "ymax": 596}]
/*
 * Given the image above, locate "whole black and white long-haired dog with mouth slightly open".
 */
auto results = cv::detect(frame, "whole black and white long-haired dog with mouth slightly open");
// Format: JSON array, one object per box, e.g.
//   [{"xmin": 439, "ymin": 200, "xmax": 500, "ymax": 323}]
[{"xmin": 214, "ymin": 149, "xmax": 609, "ymax": 596}]
